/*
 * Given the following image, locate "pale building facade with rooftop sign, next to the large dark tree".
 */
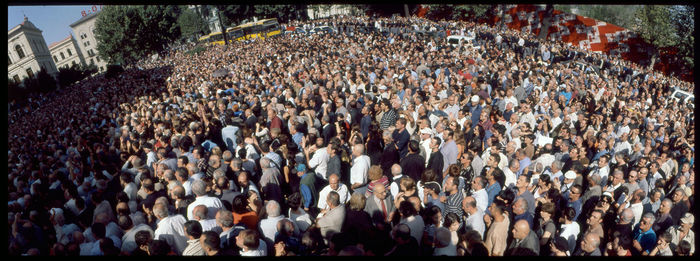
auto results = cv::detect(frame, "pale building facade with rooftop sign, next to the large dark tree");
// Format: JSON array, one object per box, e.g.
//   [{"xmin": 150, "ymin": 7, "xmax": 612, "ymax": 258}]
[{"xmin": 70, "ymin": 12, "xmax": 107, "ymax": 72}]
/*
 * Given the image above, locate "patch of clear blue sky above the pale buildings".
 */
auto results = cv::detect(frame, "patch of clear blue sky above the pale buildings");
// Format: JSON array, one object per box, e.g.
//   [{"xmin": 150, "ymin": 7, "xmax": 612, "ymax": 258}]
[{"xmin": 7, "ymin": 5, "xmax": 99, "ymax": 45}]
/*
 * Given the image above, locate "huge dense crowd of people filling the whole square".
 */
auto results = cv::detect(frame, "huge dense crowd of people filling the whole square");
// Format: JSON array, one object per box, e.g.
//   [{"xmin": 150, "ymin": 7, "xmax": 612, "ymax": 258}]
[{"xmin": 8, "ymin": 12, "xmax": 695, "ymax": 256}]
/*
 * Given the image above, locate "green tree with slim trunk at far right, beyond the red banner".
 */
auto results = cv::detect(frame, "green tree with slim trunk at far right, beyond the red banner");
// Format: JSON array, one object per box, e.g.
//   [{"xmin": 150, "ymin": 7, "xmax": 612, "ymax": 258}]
[{"xmin": 634, "ymin": 5, "xmax": 678, "ymax": 68}]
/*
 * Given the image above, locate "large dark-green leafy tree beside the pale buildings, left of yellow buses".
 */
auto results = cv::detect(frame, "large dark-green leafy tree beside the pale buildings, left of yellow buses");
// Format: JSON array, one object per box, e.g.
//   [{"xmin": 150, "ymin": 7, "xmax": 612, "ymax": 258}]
[{"xmin": 95, "ymin": 5, "xmax": 180, "ymax": 64}]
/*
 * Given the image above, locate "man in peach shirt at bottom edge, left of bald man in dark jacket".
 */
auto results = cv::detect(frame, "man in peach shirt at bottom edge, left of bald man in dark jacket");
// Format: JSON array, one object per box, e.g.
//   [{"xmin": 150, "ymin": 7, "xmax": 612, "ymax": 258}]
[{"xmin": 484, "ymin": 199, "xmax": 510, "ymax": 256}]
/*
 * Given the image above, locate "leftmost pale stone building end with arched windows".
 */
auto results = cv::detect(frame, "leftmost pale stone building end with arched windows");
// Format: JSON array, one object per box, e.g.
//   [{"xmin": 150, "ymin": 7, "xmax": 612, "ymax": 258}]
[{"xmin": 7, "ymin": 17, "xmax": 58, "ymax": 83}]
